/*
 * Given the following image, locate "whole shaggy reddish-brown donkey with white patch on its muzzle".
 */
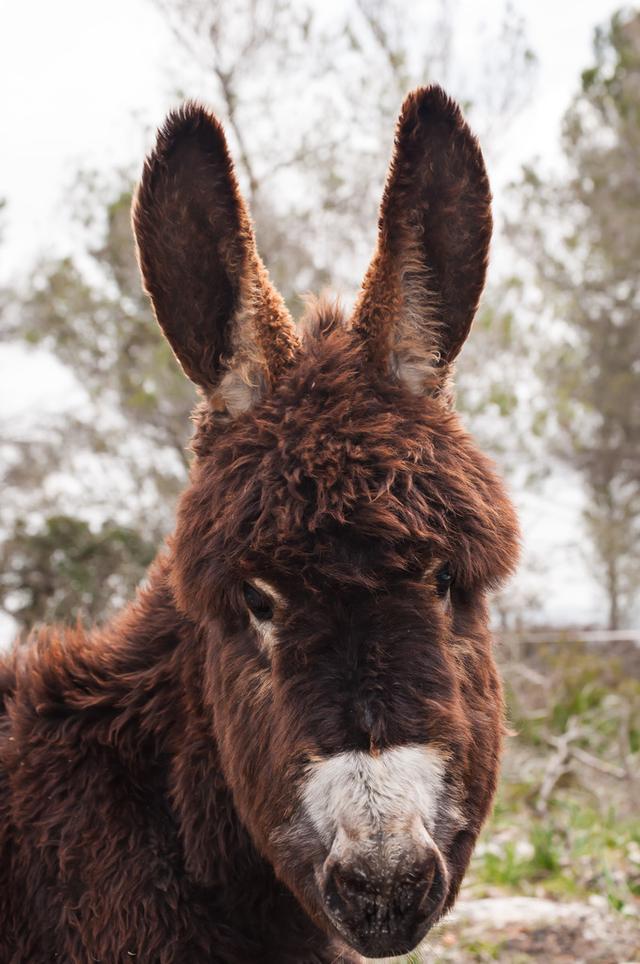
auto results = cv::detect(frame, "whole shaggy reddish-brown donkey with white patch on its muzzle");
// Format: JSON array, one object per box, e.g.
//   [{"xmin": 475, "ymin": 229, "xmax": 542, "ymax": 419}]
[{"xmin": 0, "ymin": 87, "xmax": 518, "ymax": 964}]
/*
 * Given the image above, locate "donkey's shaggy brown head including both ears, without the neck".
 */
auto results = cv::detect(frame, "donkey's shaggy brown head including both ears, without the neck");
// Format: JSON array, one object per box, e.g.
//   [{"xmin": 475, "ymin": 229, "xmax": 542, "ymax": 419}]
[{"xmin": 134, "ymin": 88, "xmax": 517, "ymax": 956}]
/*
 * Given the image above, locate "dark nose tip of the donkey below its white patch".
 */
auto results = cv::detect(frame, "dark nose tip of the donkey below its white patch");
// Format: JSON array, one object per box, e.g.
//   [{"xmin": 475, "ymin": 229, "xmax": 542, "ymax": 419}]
[{"xmin": 322, "ymin": 848, "xmax": 446, "ymax": 957}]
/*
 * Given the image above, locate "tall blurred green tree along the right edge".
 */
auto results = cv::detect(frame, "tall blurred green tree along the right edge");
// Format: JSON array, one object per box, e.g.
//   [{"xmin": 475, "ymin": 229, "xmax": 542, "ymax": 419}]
[{"xmin": 512, "ymin": 12, "xmax": 640, "ymax": 628}]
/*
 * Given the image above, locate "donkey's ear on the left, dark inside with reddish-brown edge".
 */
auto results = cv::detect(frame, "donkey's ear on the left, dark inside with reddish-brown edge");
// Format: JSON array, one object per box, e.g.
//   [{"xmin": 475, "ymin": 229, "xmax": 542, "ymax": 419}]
[{"xmin": 133, "ymin": 104, "xmax": 298, "ymax": 415}]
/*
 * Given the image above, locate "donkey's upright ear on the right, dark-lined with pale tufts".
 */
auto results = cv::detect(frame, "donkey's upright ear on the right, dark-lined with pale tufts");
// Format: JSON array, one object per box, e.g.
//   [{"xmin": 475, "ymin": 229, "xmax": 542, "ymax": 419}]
[{"xmin": 352, "ymin": 87, "xmax": 492, "ymax": 392}]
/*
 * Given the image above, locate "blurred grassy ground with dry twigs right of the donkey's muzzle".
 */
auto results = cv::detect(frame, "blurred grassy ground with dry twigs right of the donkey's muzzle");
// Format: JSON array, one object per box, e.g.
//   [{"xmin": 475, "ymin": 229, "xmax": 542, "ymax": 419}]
[{"xmin": 469, "ymin": 642, "xmax": 640, "ymax": 913}]
